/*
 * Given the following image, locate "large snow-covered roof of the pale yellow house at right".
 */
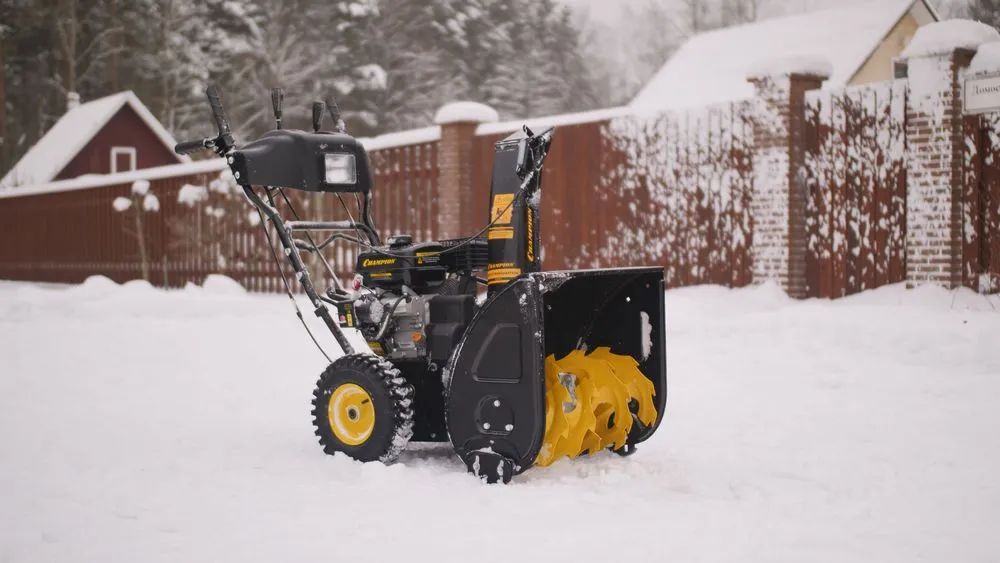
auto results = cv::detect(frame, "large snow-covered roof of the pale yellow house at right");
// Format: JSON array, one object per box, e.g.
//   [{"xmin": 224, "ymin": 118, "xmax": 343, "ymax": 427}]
[{"xmin": 630, "ymin": 0, "xmax": 938, "ymax": 109}]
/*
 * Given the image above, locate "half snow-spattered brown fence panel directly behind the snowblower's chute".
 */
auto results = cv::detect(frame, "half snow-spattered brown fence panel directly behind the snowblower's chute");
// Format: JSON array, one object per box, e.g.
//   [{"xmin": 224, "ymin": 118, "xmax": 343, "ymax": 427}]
[{"xmin": 473, "ymin": 101, "xmax": 753, "ymax": 287}]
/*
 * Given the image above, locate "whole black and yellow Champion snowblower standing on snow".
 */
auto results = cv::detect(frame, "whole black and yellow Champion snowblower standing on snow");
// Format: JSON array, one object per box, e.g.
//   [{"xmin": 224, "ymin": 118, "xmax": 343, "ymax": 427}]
[{"xmin": 175, "ymin": 86, "xmax": 667, "ymax": 483}]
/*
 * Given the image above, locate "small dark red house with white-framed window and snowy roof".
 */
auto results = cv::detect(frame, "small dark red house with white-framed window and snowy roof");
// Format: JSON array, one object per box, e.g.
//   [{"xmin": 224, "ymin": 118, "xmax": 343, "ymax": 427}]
[{"xmin": 0, "ymin": 91, "xmax": 190, "ymax": 187}]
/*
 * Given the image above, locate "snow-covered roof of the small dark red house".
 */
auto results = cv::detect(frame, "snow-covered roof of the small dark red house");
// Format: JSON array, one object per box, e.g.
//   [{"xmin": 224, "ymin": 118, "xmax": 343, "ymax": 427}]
[{"xmin": 0, "ymin": 91, "xmax": 191, "ymax": 186}]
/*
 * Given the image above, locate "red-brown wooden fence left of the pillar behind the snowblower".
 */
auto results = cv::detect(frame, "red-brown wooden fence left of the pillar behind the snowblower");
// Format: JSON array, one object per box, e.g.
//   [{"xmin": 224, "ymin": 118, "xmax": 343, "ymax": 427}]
[{"xmin": 0, "ymin": 141, "xmax": 437, "ymax": 292}]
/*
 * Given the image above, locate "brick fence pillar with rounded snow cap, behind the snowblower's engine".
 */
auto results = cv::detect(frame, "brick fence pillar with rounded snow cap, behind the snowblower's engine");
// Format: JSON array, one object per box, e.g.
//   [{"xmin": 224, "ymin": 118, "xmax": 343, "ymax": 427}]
[{"xmin": 434, "ymin": 102, "xmax": 499, "ymax": 239}]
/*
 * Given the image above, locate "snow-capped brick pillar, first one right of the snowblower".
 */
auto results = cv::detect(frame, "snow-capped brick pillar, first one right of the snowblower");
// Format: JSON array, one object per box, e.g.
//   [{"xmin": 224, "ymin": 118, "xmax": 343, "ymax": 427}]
[{"xmin": 747, "ymin": 59, "xmax": 830, "ymax": 298}]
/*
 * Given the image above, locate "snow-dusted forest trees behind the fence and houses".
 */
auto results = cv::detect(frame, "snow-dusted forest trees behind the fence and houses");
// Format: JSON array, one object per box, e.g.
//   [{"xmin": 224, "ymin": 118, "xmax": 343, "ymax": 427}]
[{"xmin": 0, "ymin": 0, "xmax": 988, "ymax": 178}]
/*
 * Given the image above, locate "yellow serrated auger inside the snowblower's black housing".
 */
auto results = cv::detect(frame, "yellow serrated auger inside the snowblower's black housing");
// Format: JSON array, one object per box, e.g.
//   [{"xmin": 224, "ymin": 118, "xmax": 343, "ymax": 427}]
[{"xmin": 535, "ymin": 347, "xmax": 656, "ymax": 466}]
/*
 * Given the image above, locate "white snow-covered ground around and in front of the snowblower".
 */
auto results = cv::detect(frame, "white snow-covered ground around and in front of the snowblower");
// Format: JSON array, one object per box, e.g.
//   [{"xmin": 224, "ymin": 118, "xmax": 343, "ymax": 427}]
[{"xmin": 0, "ymin": 282, "xmax": 1000, "ymax": 563}]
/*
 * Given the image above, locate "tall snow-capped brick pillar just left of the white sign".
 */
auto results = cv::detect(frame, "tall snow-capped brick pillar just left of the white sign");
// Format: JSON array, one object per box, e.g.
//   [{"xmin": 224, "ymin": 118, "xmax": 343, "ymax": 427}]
[{"xmin": 901, "ymin": 20, "xmax": 1000, "ymax": 287}]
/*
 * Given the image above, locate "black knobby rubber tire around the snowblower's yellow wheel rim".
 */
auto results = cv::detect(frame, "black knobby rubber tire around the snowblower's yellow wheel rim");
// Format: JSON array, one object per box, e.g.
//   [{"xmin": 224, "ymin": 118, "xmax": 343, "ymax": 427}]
[{"xmin": 312, "ymin": 354, "xmax": 413, "ymax": 465}]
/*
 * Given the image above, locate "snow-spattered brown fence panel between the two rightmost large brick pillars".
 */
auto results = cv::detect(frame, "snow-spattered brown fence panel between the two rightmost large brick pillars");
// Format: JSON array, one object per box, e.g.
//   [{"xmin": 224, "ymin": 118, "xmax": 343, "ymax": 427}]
[{"xmin": 805, "ymin": 81, "xmax": 906, "ymax": 297}]
